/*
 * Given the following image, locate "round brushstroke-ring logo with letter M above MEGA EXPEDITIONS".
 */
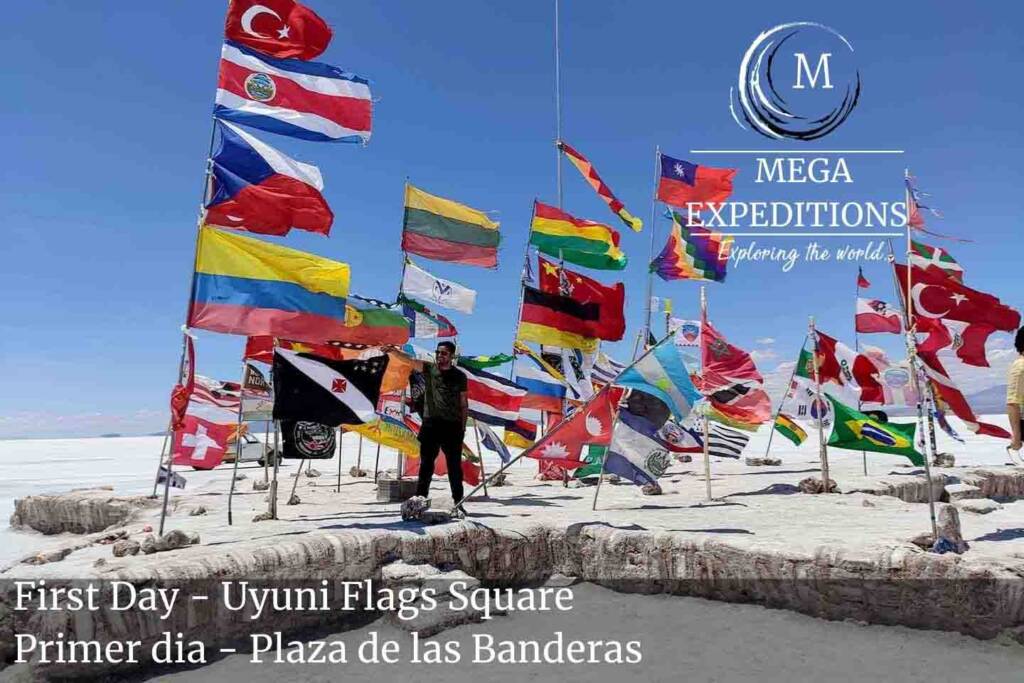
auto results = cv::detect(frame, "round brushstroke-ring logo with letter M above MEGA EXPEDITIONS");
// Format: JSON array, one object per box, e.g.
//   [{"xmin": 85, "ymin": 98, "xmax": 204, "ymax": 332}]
[{"xmin": 729, "ymin": 22, "xmax": 860, "ymax": 141}]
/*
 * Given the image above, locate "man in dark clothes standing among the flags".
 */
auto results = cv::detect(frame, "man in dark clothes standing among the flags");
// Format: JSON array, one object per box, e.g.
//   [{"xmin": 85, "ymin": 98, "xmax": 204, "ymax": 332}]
[{"xmin": 416, "ymin": 341, "xmax": 469, "ymax": 503}]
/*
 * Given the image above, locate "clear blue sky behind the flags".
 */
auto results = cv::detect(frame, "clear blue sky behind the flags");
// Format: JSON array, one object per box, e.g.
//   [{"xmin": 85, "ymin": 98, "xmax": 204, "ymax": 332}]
[{"xmin": 0, "ymin": 0, "xmax": 1024, "ymax": 437}]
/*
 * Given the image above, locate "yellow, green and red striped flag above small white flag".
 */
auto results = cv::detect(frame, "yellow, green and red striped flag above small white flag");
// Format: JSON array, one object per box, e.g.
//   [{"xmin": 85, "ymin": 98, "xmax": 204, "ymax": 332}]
[{"xmin": 401, "ymin": 184, "xmax": 501, "ymax": 268}]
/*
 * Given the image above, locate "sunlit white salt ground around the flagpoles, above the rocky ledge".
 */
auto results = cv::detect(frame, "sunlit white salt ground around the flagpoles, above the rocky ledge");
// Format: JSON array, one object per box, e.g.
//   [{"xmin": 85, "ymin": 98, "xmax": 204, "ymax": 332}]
[{"xmin": 0, "ymin": 417, "xmax": 1024, "ymax": 575}]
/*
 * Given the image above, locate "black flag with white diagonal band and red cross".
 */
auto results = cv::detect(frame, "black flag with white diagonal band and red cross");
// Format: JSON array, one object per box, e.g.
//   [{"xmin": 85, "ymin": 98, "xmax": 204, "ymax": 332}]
[{"xmin": 273, "ymin": 348, "xmax": 389, "ymax": 427}]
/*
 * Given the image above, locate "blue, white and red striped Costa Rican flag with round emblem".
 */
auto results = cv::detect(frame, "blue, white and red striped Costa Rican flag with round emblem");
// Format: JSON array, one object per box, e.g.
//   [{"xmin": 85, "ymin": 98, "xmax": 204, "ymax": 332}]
[{"xmin": 213, "ymin": 41, "xmax": 373, "ymax": 143}]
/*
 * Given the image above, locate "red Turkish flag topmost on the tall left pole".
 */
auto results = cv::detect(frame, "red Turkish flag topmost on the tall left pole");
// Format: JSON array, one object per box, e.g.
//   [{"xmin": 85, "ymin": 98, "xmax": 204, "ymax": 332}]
[{"xmin": 224, "ymin": 0, "xmax": 333, "ymax": 59}]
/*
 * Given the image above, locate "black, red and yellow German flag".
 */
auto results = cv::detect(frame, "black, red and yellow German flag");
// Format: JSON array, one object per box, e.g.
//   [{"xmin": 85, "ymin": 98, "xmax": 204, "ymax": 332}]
[{"xmin": 518, "ymin": 286, "xmax": 601, "ymax": 351}]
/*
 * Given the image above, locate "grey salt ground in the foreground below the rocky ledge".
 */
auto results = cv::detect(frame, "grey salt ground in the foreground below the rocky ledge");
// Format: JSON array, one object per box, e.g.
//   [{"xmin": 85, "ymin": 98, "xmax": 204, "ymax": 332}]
[{"xmin": 152, "ymin": 585, "xmax": 1024, "ymax": 683}]
